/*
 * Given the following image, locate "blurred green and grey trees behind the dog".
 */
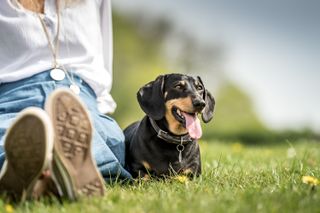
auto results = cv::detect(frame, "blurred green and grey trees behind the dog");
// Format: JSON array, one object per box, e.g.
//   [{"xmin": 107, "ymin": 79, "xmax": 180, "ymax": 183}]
[{"xmin": 112, "ymin": 11, "xmax": 314, "ymax": 143}]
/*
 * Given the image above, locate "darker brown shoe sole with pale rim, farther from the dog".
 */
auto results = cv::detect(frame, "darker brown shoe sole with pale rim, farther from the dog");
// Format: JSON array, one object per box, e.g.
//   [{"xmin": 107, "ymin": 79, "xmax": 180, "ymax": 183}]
[{"xmin": 0, "ymin": 107, "xmax": 53, "ymax": 202}]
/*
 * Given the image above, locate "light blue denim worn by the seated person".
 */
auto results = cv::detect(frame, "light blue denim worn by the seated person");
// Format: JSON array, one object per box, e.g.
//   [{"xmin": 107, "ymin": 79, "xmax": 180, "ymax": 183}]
[{"xmin": 0, "ymin": 71, "xmax": 131, "ymax": 181}]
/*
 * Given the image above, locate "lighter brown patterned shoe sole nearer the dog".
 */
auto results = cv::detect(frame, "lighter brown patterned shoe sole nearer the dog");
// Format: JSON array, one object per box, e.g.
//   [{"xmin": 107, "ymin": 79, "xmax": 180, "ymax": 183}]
[{"xmin": 45, "ymin": 89, "xmax": 105, "ymax": 200}]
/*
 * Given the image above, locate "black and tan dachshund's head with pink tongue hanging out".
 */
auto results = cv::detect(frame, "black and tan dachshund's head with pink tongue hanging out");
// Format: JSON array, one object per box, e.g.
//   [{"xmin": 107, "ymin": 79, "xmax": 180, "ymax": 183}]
[{"xmin": 137, "ymin": 74, "xmax": 215, "ymax": 139}]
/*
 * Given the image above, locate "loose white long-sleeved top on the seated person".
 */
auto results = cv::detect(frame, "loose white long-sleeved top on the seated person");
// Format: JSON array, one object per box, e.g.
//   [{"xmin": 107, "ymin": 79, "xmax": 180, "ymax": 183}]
[{"xmin": 0, "ymin": 0, "xmax": 116, "ymax": 113}]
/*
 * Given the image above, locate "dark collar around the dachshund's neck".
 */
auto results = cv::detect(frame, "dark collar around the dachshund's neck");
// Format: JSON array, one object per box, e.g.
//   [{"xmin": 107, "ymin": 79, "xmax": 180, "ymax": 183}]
[{"xmin": 149, "ymin": 117, "xmax": 194, "ymax": 145}]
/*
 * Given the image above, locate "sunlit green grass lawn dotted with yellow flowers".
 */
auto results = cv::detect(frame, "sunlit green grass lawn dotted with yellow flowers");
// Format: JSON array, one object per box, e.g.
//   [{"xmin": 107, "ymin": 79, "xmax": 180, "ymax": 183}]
[{"xmin": 0, "ymin": 141, "xmax": 320, "ymax": 213}]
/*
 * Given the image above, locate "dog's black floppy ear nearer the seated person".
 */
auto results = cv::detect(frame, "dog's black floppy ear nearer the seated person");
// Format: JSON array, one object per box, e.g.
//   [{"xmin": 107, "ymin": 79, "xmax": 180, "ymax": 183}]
[{"xmin": 137, "ymin": 75, "xmax": 166, "ymax": 120}]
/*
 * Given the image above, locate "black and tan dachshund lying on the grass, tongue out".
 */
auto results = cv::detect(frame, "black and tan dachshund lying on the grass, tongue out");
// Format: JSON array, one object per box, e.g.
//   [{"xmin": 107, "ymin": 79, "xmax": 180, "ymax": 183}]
[{"xmin": 124, "ymin": 74, "xmax": 215, "ymax": 177}]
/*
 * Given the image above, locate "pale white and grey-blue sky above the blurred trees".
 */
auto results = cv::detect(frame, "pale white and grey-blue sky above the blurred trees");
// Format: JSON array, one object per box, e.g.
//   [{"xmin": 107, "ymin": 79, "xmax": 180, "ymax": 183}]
[{"xmin": 113, "ymin": 0, "xmax": 320, "ymax": 131}]
